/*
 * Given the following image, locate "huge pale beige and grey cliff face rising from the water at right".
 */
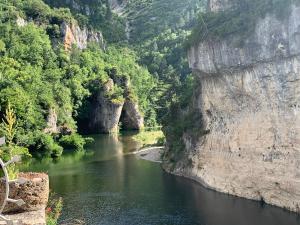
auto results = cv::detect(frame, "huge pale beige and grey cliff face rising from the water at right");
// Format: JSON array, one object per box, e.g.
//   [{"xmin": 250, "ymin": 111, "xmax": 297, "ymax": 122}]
[{"xmin": 164, "ymin": 0, "xmax": 300, "ymax": 212}]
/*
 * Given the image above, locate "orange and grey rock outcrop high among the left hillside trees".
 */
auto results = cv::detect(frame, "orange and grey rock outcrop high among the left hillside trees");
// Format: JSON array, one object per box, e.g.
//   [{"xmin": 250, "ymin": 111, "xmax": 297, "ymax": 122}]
[{"xmin": 61, "ymin": 22, "xmax": 105, "ymax": 50}]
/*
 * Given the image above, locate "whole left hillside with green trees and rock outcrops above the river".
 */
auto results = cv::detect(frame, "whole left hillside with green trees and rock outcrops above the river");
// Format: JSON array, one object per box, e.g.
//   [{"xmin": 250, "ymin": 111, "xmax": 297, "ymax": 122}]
[{"xmin": 0, "ymin": 0, "xmax": 156, "ymax": 156}]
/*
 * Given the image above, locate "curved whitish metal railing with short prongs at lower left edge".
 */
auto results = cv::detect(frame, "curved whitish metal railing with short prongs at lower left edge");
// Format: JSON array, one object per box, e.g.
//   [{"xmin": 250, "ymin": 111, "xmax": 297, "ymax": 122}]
[{"xmin": 0, "ymin": 138, "xmax": 26, "ymax": 225}]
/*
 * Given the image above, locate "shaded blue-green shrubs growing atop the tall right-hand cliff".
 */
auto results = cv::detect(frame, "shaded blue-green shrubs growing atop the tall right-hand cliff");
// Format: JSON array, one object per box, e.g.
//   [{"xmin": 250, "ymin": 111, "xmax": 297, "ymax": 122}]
[{"xmin": 186, "ymin": 0, "xmax": 299, "ymax": 47}]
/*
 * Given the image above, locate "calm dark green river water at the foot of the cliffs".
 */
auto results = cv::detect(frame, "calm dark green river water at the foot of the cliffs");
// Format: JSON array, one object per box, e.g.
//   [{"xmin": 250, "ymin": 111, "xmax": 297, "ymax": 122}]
[{"xmin": 24, "ymin": 135, "xmax": 300, "ymax": 225}]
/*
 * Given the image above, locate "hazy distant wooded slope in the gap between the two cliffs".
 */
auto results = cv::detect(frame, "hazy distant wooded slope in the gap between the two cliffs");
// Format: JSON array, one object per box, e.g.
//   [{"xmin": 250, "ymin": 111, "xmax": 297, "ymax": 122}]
[{"xmin": 121, "ymin": 0, "xmax": 205, "ymax": 126}]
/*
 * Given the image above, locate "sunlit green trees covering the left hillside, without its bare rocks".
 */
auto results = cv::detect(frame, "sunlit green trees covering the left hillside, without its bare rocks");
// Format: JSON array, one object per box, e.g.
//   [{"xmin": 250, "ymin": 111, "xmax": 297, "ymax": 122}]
[{"xmin": 0, "ymin": 0, "xmax": 156, "ymax": 157}]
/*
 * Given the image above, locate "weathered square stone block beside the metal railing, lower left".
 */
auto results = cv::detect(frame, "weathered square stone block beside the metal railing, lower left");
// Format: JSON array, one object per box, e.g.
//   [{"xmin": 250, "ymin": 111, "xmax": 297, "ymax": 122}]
[{"xmin": 0, "ymin": 173, "xmax": 49, "ymax": 213}]
